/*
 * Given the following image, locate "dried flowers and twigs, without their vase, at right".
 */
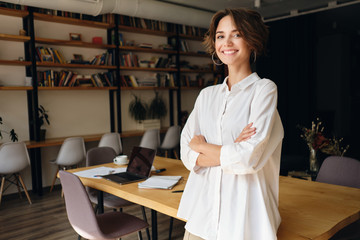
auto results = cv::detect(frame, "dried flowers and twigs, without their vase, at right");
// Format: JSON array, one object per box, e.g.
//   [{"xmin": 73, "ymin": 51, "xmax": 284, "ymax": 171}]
[{"xmin": 298, "ymin": 118, "xmax": 349, "ymax": 156}]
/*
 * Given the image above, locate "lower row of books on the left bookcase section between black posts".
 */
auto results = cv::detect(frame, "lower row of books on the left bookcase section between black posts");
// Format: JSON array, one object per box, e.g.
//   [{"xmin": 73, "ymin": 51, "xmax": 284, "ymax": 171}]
[{"xmin": 37, "ymin": 70, "xmax": 114, "ymax": 87}]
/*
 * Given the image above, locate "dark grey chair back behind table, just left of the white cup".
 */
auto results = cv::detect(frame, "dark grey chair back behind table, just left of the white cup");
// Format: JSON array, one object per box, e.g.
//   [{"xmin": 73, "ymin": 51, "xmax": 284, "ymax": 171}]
[{"xmin": 86, "ymin": 147, "xmax": 116, "ymax": 166}]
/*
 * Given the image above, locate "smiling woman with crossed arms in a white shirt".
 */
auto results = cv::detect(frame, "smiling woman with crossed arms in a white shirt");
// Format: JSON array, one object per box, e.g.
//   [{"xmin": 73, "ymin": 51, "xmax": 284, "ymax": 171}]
[{"xmin": 178, "ymin": 9, "xmax": 283, "ymax": 240}]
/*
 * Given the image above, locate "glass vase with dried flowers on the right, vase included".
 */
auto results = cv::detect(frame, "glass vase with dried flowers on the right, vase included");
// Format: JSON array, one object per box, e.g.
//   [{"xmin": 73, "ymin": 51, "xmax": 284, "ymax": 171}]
[{"xmin": 298, "ymin": 118, "xmax": 349, "ymax": 173}]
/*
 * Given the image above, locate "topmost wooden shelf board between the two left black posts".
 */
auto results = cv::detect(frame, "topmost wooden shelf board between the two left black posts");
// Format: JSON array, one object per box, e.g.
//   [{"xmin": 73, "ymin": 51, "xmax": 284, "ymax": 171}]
[{"xmin": 34, "ymin": 13, "xmax": 114, "ymax": 29}]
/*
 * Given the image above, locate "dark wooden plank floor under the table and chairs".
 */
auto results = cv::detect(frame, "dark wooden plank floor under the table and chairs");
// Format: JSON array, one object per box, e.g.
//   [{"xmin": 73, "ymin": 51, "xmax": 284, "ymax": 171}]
[{"xmin": 0, "ymin": 190, "xmax": 184, "ymax": 240}]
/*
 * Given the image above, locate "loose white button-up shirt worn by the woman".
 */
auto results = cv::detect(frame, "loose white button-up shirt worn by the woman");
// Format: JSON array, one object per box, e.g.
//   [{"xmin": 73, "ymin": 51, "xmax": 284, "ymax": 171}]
[{"xmin": 178, "ymin": 73, "xmax": 284, "ymax": 240}]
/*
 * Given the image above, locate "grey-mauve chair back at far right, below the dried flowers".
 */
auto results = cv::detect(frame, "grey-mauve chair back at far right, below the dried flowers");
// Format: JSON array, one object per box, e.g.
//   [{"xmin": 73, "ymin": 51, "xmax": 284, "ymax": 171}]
[{"xmin": 316, "ymin": 156, "xmax": 360, "ymax": 188}]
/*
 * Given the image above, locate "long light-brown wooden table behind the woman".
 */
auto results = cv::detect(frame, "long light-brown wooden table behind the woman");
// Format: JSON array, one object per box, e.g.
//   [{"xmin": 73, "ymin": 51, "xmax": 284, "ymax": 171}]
[{"xmin": 70, "ymin": 157, "xmax": 360, "ymax": 240}]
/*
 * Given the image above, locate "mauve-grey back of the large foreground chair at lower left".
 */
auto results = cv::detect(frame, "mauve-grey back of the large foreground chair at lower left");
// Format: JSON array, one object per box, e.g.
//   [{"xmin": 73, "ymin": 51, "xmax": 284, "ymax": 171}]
[{"xmin": 59, "ymin": 170, "xmax": 102, "ymax": 239}]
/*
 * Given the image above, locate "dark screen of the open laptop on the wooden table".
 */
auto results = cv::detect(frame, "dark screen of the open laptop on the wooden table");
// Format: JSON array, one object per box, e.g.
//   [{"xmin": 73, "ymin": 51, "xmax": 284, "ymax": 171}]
[{"xmin": 126, "ymin": 147, "xmax": 156, "ymax": 177}]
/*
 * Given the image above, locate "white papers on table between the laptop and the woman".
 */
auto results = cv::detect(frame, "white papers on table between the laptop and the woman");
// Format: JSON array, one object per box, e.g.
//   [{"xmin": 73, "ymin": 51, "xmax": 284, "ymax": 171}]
[{"xmin": 138, "ymin": 176, "xmax": 181, "ymax": 189}]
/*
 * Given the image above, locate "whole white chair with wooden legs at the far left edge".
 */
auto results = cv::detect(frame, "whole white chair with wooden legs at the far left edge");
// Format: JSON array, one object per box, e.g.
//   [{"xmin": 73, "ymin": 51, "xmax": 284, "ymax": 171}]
[{"xmin": 0, "ymin": 142, "xmax": 31, "ymax": 204}]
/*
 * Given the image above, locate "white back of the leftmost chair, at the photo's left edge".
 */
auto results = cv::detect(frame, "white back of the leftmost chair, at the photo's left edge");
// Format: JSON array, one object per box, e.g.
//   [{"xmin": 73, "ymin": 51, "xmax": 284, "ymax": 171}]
[{"xmin": 0, "ymin": 142, "xmax": 30, "ymax": 175}]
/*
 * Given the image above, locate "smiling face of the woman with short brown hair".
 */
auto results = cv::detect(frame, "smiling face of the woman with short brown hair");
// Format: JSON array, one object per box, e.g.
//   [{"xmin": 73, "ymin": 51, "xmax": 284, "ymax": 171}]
[{"xmin": 215, "ymin": 16, "xmax": 251, "ymax": 65}]
